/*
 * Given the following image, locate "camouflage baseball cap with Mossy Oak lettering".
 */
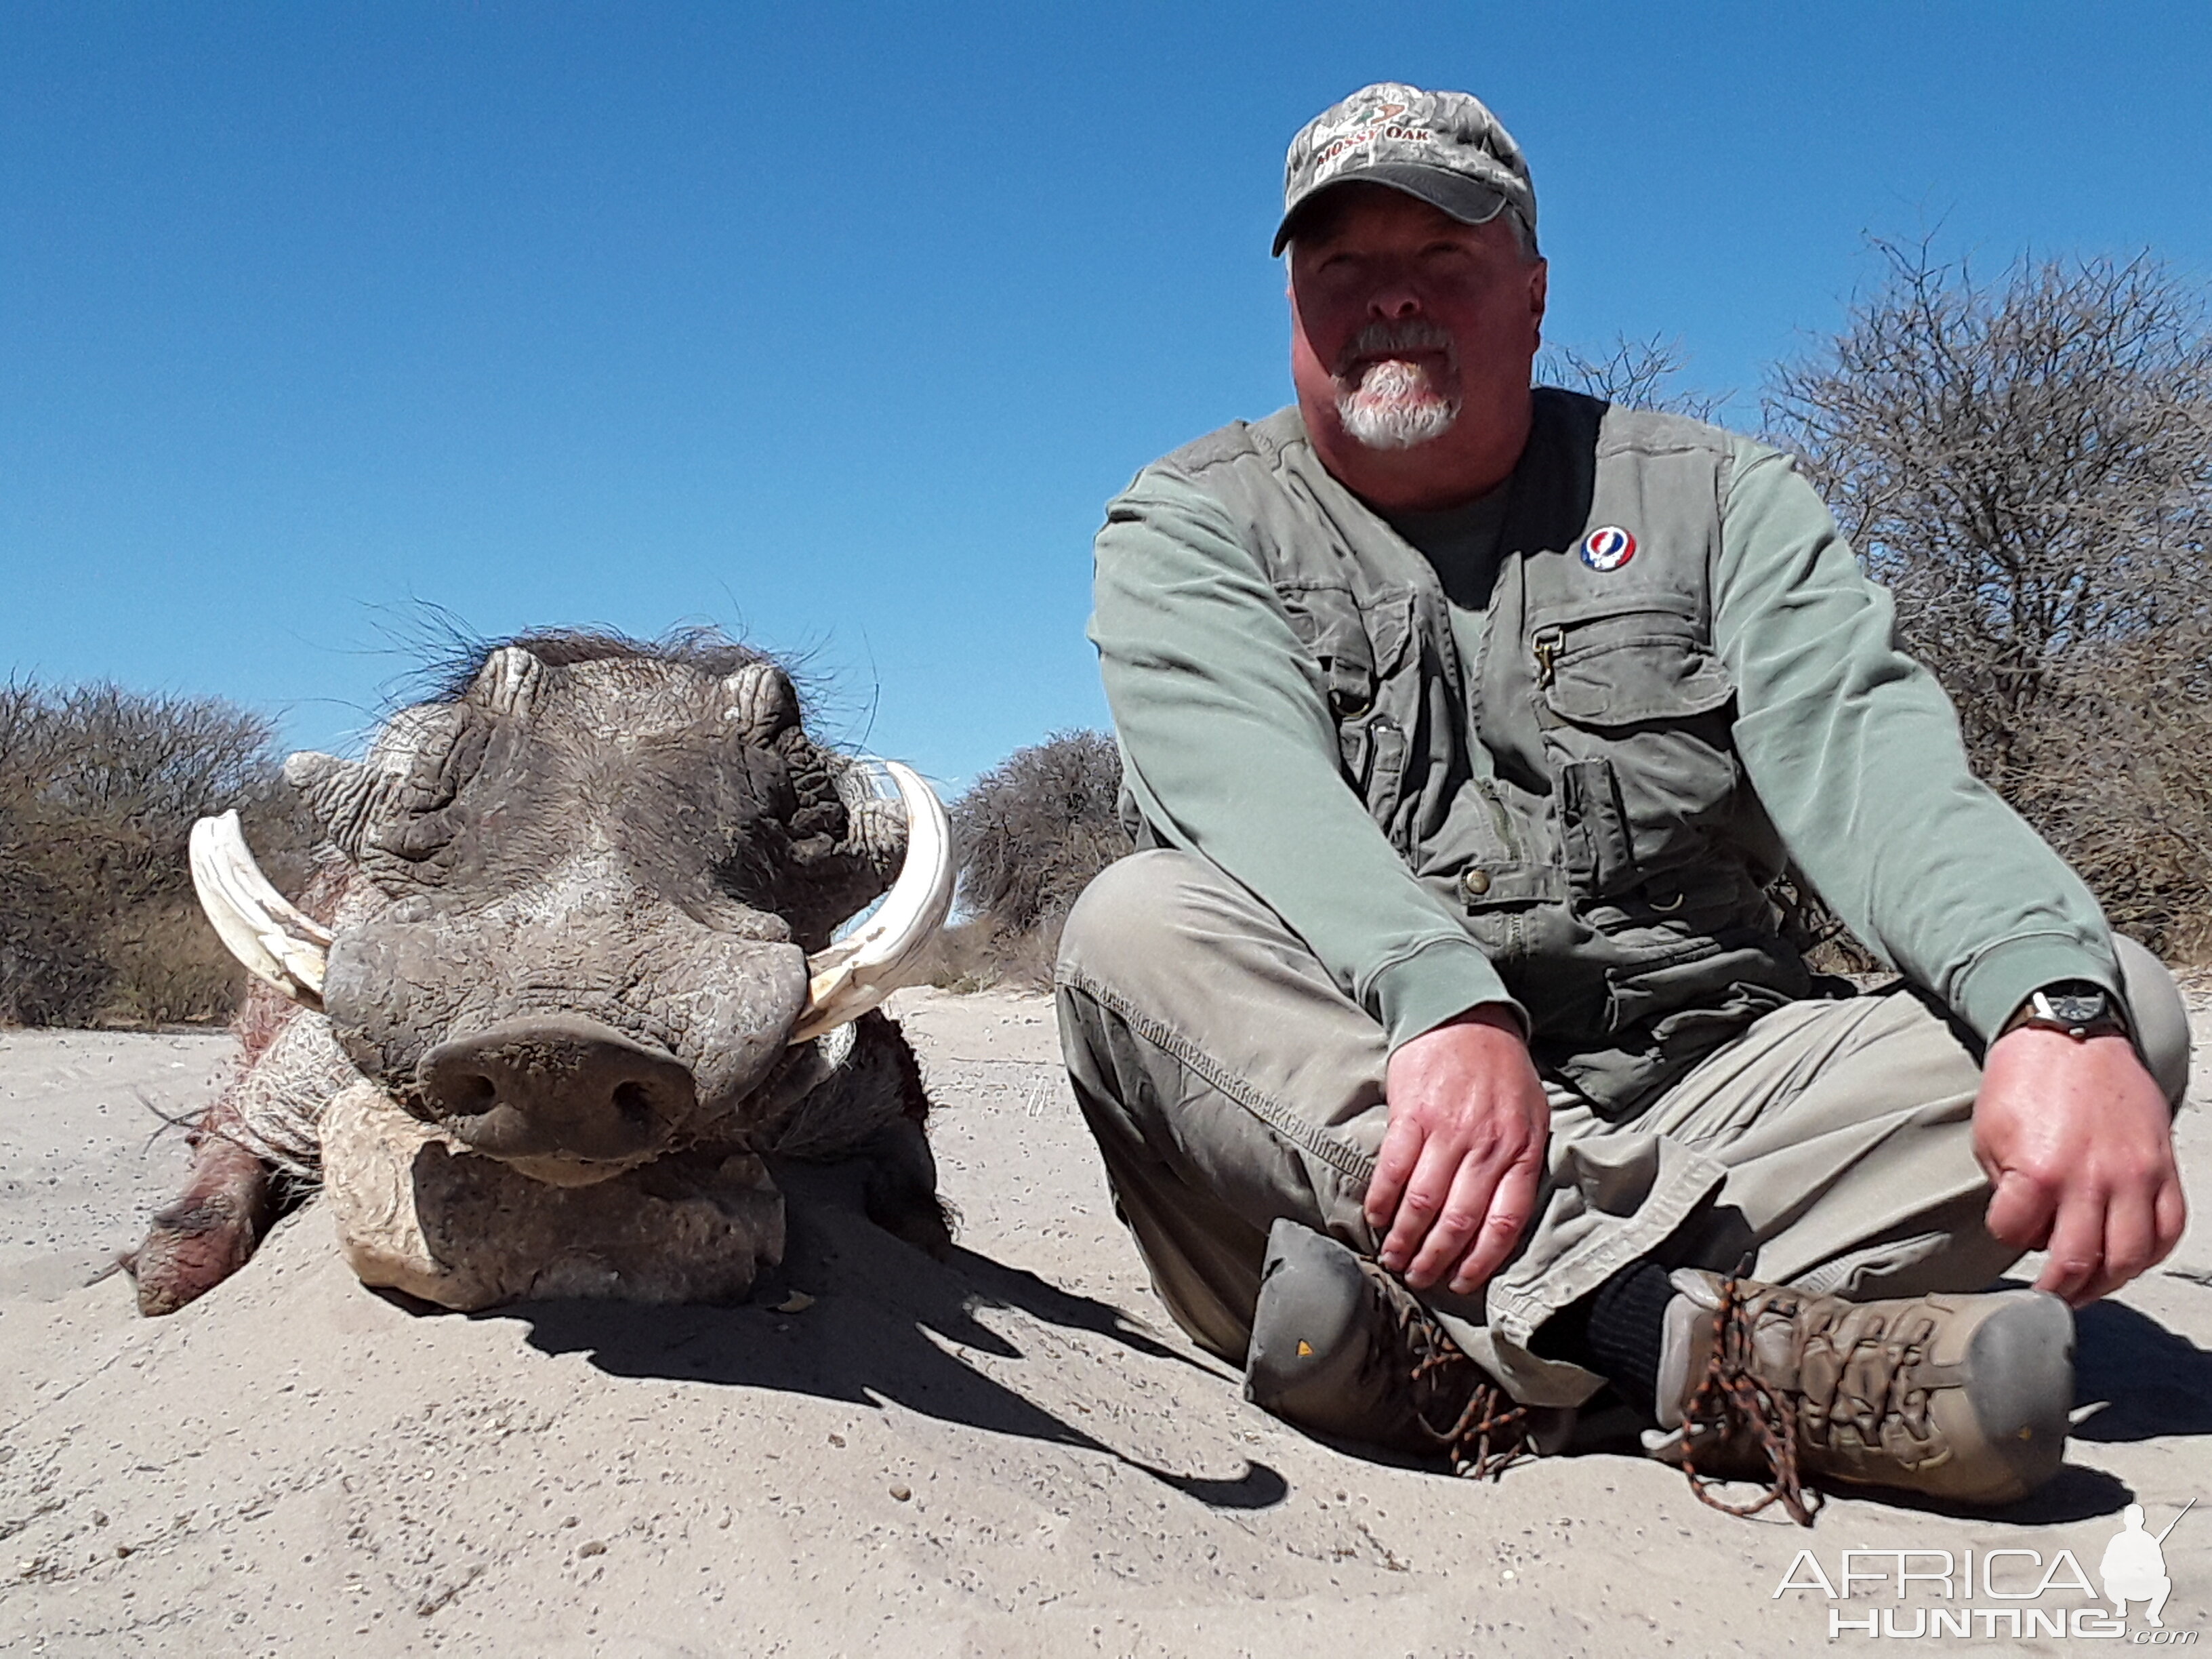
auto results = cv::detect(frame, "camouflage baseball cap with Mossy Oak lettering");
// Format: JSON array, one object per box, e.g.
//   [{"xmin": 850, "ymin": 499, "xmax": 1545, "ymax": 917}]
[{"xmin": 1274, "ymin": 80, "xmax": 1535, "ymax": 252}]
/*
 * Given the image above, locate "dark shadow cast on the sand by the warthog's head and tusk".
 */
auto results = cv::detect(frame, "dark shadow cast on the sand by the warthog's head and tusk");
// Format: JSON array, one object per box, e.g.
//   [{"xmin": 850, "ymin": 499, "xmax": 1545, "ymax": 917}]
[{"xmin": 471, "ymin": 1176, "xmax": 1290, "ymax": 1509}]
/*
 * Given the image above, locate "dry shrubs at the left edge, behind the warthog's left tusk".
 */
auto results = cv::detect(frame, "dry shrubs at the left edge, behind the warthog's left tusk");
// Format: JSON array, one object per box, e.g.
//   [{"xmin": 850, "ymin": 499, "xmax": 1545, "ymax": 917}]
[{"xmin": 0, "ymin": 681, "xmax": 310, "ymax": 1024}]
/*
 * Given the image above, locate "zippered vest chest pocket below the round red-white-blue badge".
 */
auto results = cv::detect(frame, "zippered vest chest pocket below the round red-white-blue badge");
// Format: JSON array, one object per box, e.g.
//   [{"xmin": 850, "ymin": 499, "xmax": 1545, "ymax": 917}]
[{"xmin": 1528, "ymin": 611, "xmax": 1741, "ymax": 896}]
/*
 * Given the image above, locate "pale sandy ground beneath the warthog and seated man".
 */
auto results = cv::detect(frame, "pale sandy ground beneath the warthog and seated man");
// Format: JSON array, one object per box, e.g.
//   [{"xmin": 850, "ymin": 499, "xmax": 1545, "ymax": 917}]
[{"xmin": 0, "ymin": 994, "xmax": 2212, "ymax": 1659}]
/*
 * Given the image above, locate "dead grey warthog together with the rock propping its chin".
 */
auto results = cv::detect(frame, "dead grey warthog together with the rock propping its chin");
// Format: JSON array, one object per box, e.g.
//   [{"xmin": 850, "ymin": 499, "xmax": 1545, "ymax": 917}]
[{"xmin": 133, "ymin": 633, "xmax": 954, "ymax": 1314}]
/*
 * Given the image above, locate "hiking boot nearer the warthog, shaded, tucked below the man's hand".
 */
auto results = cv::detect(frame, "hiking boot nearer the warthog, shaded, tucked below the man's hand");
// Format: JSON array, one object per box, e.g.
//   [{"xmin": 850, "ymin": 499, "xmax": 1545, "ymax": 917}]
[{"xmin": 1246, "ymin": 1221, "xmax": 1573, "ymax": 1477}]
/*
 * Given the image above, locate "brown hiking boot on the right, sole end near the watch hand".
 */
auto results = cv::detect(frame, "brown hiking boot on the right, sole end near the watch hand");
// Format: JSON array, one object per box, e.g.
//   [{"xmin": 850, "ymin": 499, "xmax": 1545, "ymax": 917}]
[{"xmin": 1652, "ymin": 1270, "xmax": 2072, "ymax": 1524}]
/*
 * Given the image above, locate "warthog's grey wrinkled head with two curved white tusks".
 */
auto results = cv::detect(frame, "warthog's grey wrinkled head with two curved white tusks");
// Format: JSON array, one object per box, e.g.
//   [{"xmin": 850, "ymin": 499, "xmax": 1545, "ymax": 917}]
[{"xmin": 192, "ymin": 635, "xmax": 951, "ymax": 1186}]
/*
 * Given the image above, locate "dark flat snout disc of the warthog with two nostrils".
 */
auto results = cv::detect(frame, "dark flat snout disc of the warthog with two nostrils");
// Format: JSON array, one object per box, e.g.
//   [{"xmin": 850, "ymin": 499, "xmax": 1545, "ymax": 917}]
[{"xmin": 418, "ymin": 1015, "xmax": 693, "ymax": 1164}]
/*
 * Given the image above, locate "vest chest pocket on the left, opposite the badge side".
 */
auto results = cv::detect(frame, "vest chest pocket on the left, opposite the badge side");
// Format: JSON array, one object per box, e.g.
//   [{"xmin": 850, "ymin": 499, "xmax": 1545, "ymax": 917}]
[{"xmin": 1276, "ymin": 584, "xmax": 1414, "ymax": 823}]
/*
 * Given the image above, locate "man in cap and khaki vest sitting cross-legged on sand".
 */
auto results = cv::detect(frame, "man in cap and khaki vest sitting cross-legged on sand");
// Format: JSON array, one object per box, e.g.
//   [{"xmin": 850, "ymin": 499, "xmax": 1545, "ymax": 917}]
[{"xmin": 1059, "ymin": 84, "xmax": 2188, "ymax": 1519}]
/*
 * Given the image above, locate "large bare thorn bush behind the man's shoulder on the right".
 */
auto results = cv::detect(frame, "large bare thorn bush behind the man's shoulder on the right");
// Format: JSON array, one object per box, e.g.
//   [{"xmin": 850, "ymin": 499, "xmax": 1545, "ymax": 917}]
[{"xmin": 1765, "ymin": 241, "xmax": 2212, "ymax": 956}]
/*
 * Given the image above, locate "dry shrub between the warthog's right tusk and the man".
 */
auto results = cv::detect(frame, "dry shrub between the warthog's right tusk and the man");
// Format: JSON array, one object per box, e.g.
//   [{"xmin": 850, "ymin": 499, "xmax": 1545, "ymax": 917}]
[{"xmin": 929, "ymin": 732, "xmax": 1132, "ymax": 991}]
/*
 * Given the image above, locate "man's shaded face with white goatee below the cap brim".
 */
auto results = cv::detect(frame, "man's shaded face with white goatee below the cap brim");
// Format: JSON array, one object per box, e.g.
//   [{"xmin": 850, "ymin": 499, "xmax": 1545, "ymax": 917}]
[{"xmin": 1290, "ymin": 184, "xmax": 1544, "ymax": 471}]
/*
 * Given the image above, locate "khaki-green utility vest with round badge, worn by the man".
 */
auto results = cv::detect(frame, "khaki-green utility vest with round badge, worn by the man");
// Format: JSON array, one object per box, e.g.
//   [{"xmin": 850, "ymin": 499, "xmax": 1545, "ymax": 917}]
[{"xmin": 1159, "ymin": 387, "xmax": 1811, "ymax": 1117}]
